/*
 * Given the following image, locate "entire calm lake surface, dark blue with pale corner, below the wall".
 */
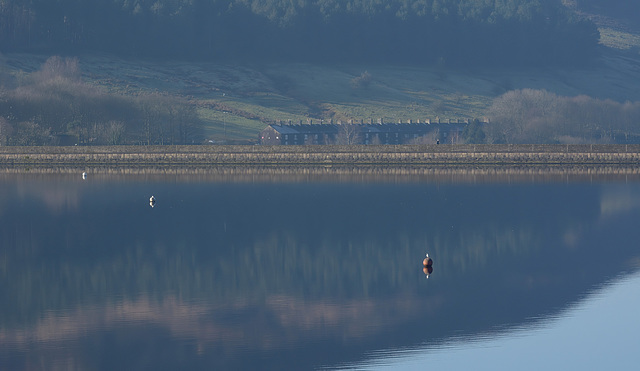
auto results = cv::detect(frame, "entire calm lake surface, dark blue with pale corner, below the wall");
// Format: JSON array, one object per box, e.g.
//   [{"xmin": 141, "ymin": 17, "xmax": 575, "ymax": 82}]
[{"xmin": 0, "ymin": 170, "xmax": 640, "ymax": 370}]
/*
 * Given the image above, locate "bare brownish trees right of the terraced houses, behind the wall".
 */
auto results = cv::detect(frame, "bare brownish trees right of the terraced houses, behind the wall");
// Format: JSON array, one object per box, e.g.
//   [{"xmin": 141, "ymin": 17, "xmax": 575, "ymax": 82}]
[{"xmin": 484, "ymin": 89, "xmax": 640, "ymax": 144}]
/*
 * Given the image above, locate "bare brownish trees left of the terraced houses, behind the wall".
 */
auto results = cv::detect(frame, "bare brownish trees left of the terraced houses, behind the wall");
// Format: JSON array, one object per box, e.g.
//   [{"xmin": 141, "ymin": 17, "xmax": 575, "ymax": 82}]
[{"xmin": 0, "ymin": 56, "xmax": 202, "ymax": 145}]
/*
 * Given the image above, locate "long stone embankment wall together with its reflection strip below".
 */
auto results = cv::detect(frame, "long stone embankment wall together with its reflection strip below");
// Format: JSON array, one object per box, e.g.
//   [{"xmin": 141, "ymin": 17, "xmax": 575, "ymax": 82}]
[{"xmin": 0, "ymin": 145, "xmax": 640, "ymax": 183}]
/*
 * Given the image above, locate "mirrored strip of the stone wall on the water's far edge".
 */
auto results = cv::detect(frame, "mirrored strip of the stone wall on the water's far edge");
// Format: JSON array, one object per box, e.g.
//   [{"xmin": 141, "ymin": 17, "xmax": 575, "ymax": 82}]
[{"xmin": 0, "ymin": 164, "xmax": 640, "ymax": 183}]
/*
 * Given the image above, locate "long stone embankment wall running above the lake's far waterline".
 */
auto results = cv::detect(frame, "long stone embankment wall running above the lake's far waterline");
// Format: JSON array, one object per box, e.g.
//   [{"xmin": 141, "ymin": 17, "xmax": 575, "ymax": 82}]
[{"xmin": 0, "ymin": 145, "xmax": 640, "ymax": 168}]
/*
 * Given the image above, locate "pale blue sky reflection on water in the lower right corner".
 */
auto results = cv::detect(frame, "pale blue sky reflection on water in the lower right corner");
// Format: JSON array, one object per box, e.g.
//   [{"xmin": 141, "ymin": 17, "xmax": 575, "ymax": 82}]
[{"xmin": 344, "ymin": 273, "xmax": 640, "ymax": 370}]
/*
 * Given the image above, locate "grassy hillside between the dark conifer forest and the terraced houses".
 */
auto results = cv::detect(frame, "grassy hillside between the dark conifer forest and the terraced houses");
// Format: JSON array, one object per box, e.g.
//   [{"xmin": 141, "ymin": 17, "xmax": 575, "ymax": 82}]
[{"xmin": 0, "ymin": 13, "xmax": 640, "ymax": 142}]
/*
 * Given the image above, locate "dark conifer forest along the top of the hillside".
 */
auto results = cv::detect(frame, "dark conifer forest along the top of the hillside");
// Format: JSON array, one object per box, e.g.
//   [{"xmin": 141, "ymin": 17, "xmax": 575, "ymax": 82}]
[{"xmin": 0, "ymin": 0, "xmax": 599, "ymax": 66}]
